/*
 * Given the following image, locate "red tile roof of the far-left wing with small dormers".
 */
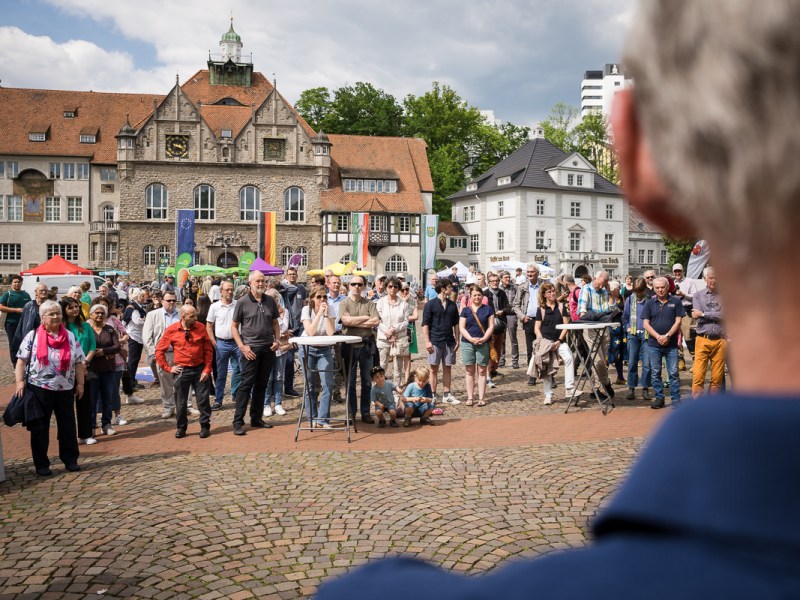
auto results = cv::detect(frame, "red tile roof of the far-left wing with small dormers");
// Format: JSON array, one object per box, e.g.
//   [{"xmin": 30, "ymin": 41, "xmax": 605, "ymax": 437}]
[{"xmin": 0, "ymin": 88, "xmax": 163, "ymax": 164}]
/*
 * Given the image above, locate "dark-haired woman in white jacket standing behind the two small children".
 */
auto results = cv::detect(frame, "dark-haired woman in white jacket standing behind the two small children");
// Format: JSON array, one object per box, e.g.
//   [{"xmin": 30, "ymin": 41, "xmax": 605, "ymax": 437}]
[{"xmin": 375, "ymin": 277, "xmax": 411, "ymax": 383}]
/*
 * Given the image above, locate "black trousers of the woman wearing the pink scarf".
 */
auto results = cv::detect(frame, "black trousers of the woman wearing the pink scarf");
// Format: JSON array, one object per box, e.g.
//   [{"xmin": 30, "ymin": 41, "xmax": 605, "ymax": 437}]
[{"xmin": 27, "ymin": 385, "xmax": 80, "ymax": 469}]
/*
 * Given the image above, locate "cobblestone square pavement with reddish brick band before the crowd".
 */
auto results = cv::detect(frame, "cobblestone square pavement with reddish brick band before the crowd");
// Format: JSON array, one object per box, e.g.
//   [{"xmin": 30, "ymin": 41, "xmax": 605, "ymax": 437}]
[{"xmin": 0, "ymin": 336, "xmax": 688, "ymax": 599}]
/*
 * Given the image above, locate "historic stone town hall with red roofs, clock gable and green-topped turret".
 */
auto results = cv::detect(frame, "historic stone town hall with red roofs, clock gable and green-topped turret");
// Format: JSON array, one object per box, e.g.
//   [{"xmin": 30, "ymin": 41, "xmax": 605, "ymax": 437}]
[{"xmin": 0, "ymin": 24, "xmax": 433, "ymax": 278}]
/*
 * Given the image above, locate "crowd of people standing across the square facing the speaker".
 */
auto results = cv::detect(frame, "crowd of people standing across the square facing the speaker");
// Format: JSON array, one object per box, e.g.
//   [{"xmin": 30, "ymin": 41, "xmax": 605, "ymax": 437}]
[{"xmin": 0, "ymin": 264, "xmax": 726, "ymax": 473}]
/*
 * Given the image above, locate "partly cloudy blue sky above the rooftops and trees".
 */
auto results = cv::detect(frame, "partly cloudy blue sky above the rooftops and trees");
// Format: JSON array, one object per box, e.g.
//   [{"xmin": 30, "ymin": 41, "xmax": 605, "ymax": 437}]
[{"xmin": 0, "ymin": 0, "xmax": 633, "ymax": 126}]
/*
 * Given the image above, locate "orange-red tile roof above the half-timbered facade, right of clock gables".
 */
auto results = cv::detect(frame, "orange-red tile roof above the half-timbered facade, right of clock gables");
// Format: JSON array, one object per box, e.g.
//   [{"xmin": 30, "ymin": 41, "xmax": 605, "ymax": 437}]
[{"xmin": 320, "ymin": 134, "xmax": 433, "ymax": 213}]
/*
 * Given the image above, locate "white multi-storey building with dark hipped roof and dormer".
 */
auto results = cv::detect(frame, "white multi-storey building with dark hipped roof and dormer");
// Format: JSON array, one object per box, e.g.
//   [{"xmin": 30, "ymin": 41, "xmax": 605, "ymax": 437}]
[{"xmin": 449, "ymin": 128, "xmax": 629, "ymax": 275}]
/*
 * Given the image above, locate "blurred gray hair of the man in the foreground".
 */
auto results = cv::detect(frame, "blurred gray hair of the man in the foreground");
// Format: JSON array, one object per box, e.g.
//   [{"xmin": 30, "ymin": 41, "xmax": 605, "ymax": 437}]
[{"xmin": 623, "ymin": 0, "xmax": 800, "ymax": 264}]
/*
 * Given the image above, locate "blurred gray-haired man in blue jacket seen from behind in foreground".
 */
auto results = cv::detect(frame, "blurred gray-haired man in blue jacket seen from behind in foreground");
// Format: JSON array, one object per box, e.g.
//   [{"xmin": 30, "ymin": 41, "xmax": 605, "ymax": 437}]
[{"xmin": 318, "ymin": 0, "xmax": 800, "ymax": 600}]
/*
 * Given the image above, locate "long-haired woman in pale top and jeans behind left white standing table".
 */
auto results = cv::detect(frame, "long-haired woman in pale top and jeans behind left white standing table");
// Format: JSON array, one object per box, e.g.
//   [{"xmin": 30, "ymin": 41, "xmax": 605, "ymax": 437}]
[{"xmin": 300, "ymin": 284, "xmax": 336, "ymax": 429}]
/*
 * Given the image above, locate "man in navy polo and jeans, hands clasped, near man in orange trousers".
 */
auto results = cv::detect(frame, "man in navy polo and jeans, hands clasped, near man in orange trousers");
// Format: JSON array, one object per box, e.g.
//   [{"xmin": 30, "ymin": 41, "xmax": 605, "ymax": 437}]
[{"xmin": 642, "ymin": 277, "xmax": 686, "ymax": 408}]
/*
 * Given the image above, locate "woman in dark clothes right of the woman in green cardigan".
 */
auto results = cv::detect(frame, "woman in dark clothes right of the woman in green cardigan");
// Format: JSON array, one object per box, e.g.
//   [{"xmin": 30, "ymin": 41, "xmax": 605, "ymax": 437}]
[{"xmin": 89, "ymin": 303, "xmax": 121, "ymax": 437}]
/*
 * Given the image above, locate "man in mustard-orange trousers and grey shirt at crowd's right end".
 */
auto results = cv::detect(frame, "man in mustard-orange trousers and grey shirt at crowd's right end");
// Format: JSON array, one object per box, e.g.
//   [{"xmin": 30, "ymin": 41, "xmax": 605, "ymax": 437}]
[{"xmin": 692, "ymin": 267, "xmax": 728, "ymax": 396}]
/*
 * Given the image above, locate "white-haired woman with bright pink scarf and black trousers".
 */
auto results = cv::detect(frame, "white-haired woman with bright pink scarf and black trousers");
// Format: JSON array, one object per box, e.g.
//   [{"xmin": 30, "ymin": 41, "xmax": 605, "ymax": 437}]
[{"xmin": 15, "ymin": 300, "xmax": 85, "ymax": 477}]
